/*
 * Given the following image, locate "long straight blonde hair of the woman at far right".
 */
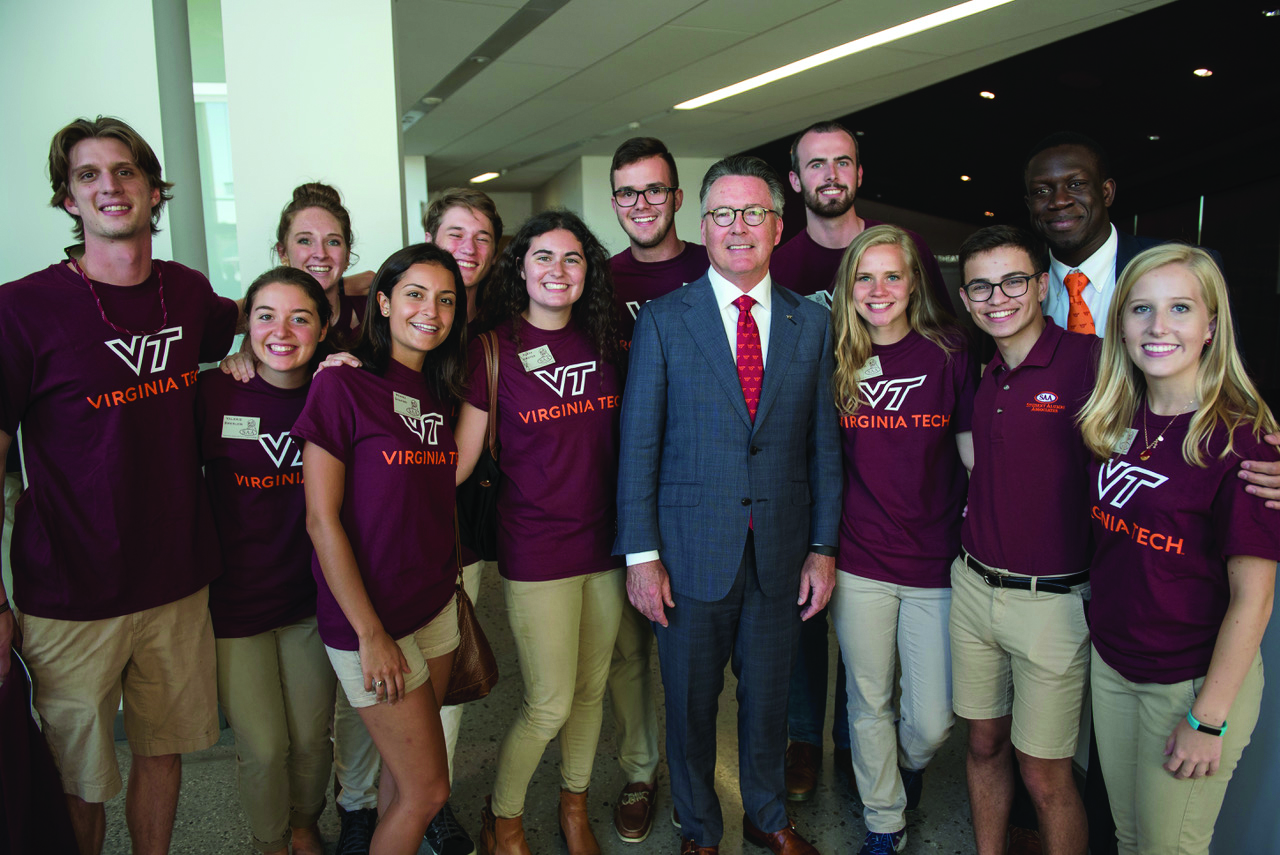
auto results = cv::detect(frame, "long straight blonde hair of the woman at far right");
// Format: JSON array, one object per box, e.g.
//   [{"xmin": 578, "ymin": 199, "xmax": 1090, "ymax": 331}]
[{"xmin": 1078, "ymin": 243, "xmax": 1276, "ymax": 466}]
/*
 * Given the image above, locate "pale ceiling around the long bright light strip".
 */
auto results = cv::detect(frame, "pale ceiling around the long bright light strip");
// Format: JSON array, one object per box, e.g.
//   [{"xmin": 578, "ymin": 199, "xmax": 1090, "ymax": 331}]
[{"xmin": 394, "ymin": 0, "xmax": 1167, "ymax": 191}]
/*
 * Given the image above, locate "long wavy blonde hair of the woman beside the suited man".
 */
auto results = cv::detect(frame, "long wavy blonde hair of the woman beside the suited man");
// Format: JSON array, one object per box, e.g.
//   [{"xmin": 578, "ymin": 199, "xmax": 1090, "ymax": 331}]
[{"xmin": 831, "ymin": 225, "xmax": 959, "ymax": 416}]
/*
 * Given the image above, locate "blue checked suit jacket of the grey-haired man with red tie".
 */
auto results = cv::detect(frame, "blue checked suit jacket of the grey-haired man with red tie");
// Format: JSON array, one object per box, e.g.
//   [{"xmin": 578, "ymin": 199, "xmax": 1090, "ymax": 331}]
[{"xmin": 613, "ymin": 275, "xmax": 841, "ymax": 602}]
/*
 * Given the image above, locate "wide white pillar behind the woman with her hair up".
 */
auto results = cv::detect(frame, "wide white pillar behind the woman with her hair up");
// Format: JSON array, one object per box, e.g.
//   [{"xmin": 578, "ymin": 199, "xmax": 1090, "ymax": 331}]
[{"xmin": 217, "ymin": 0, "xmax": 408, "ymax": 290}]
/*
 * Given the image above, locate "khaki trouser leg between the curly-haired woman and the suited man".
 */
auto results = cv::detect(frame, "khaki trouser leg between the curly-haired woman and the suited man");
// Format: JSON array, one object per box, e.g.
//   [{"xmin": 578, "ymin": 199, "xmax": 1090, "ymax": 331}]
[{"xmin": 609, "ymin": 603, "xmax": 658, "ymax": 783}]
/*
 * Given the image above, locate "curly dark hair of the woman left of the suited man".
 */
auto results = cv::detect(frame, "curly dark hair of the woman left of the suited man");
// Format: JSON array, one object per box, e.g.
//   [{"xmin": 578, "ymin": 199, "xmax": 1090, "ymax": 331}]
[{"xmin": 479, "ymin": 209, "xmax": 621, "ymax": 364}]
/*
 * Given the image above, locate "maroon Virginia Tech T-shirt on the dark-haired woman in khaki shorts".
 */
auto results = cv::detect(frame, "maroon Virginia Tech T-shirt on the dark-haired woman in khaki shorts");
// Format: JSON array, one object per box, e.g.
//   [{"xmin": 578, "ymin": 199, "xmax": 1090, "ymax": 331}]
[{"xmin": 292, "ymin": 360, "xmax": 458, "ymax": 650}]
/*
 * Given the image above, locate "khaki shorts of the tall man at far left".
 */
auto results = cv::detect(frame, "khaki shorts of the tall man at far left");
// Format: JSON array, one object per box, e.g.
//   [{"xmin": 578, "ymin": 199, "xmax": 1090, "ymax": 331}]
[{"xmin": 18, "ymin": 587, "xmax": 218, "ymax": 803}]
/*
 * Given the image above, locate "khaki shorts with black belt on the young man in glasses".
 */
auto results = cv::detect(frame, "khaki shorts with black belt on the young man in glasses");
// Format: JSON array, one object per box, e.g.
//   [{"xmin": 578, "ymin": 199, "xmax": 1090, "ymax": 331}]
[{"xmin": 951, "ymin": 558, "xmax": 1089, "ymax": 760}]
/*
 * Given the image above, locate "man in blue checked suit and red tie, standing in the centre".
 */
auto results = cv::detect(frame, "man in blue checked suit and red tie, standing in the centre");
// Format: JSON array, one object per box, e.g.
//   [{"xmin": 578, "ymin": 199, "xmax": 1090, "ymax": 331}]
[{"xmin": 614, "ymin": 156, "xmax": 841, "ymax": 855}]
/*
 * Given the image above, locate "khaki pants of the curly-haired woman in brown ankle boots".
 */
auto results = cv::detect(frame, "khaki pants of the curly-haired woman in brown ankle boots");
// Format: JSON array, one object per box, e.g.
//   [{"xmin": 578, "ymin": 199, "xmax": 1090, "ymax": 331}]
[{"xmin": 493, "ymin": 568, "xmax": 626, "ymax": 819}]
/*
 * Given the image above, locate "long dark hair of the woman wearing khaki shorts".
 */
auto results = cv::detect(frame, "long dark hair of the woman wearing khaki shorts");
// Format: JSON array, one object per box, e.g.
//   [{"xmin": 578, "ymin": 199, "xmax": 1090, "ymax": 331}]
[{"xmin": 351, "ymin": 243, "xmax": 467, "ymax": 403}]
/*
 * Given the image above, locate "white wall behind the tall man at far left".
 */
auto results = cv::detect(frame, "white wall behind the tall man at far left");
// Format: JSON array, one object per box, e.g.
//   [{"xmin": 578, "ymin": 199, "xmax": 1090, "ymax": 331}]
[{"xmin": 0, "ymin": 0, "xmax": 172, "ymax": 282}]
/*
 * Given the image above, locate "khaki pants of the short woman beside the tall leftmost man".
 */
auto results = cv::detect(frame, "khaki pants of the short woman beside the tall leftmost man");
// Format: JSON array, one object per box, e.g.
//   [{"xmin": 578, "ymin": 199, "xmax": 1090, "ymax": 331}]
[{"xmin": 218, "ymin": 617, "xmax": 335, "ymax": 852}]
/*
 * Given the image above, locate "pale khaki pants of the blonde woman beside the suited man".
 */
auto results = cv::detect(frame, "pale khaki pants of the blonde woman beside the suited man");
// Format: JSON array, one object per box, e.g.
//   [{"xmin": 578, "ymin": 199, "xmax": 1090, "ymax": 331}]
[{"xmin": 831, "ymin": 572, "xmax": 955, "ymax": 835}]
